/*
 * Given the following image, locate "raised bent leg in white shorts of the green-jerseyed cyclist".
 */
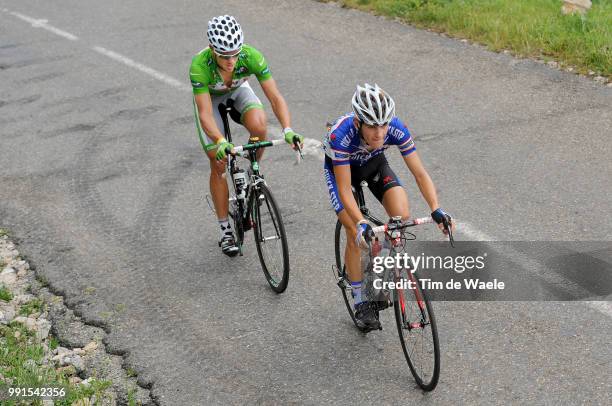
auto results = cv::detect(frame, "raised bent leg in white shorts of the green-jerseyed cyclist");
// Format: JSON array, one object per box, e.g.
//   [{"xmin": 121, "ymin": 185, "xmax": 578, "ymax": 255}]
[{"xmin": 232, "ymin": 82, "xmax": 267, "ymax": 159}]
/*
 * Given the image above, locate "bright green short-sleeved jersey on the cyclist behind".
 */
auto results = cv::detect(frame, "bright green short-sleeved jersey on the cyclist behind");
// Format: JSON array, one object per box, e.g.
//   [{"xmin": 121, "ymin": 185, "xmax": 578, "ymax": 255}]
[{"xmin": 189, "ymin": 44, "xmax": 272, "ymax": 95}]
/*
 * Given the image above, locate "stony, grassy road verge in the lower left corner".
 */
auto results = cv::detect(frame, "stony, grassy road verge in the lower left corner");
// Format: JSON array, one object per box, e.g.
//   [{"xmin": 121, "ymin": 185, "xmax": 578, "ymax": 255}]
[{"xmin": 0, "ymin": 228, "xmax": 119, "ymax": 406}]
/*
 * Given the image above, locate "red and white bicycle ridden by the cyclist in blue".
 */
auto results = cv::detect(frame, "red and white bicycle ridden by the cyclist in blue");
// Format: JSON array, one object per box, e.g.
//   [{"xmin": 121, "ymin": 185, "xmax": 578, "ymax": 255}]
[{"xmin": 332, "ymin": 181, "xmax": 453, "ymax": 391}]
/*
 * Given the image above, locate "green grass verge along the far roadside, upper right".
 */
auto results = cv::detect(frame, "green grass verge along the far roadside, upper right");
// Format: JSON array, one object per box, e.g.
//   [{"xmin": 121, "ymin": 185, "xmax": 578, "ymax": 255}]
[{"xmin": 340, "ymin": 0, "xmax": 612, "ymax": 78}]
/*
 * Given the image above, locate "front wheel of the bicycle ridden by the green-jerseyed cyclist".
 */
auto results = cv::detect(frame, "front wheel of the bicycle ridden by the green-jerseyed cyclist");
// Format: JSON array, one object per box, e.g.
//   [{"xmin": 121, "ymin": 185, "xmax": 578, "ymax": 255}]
[{"xmin": 252, "ymin": 183, "xmax": 289, "ymax": 293}]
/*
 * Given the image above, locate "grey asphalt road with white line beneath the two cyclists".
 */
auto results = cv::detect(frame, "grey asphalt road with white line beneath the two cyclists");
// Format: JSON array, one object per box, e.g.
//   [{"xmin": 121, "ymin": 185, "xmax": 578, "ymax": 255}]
[{"xmin": 0, "ymin": 0, "xmax": 612, "ymax": 405}]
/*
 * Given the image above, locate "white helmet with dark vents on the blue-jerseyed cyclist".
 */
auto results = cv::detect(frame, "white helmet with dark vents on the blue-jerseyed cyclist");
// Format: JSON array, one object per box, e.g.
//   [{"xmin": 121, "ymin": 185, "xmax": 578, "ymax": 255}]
[{"xmin": 352, "ymin": 83, "xmax": 395, "ymax": 126}]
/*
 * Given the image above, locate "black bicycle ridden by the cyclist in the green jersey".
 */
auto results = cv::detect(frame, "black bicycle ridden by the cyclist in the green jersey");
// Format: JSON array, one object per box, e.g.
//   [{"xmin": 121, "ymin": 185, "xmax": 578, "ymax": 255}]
[{"xmin": 214, "ymin": 99, "xmax": 301, "ymax": 293}]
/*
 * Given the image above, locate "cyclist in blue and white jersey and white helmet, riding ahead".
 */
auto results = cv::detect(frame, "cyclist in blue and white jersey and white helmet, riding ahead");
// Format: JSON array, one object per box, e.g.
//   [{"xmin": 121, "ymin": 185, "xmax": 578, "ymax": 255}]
[{"xmin": 323, "ymin": 83, "xmax": 454, "ymax": 330}]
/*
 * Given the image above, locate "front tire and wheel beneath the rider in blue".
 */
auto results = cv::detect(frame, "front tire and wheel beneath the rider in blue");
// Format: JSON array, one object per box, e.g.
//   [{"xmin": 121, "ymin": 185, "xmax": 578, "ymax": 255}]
[{"xmin": 393, "ymin": 269, "xmax": 440, "ymax": 392}]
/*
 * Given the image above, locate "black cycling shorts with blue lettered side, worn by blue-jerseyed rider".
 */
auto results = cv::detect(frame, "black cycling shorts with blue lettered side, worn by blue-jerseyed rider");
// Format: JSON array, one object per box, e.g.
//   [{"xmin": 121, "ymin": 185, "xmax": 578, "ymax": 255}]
[{"xmin": 323, "ymin": 154, "xmax": 402, "ymax": 214}]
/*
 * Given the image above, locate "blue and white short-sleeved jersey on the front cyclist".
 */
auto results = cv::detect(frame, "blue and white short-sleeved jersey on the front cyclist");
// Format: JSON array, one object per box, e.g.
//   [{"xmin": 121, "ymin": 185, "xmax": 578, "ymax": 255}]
[{"xmin": 323, "ymin": 113, "xmax": 416, "ymax": 166}]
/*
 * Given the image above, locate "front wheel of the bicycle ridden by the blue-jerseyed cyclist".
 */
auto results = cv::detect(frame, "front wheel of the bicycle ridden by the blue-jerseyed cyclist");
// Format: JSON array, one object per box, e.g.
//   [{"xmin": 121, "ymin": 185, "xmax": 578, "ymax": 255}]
[{"xmin": 393, "ymin": 269, "xmax": 440, "ymax": 391}]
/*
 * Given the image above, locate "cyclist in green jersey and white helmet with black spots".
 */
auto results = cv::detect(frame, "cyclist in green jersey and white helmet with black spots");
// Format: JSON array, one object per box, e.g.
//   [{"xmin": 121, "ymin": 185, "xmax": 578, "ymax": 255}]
[{"xmin": 189, "ymin": 15, "xmax": 304, "ymax": 256}]
